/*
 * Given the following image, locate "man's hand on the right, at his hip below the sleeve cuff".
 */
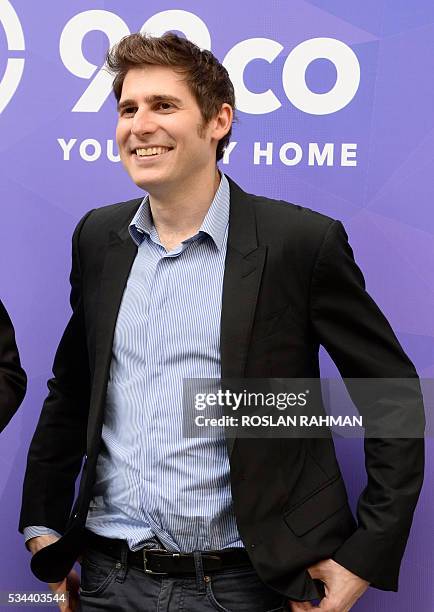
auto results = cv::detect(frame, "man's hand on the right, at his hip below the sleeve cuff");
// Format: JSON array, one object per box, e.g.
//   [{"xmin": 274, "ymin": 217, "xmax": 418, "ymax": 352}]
[{"xmin": 289, "ymin": 559, "xmax": 369, "ymax": 612}]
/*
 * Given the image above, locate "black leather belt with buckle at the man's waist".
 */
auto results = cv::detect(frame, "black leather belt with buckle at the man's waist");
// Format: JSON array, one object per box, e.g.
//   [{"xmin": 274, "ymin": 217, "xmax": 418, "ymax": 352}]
[{"xmin": 85, "ymin": 531, "xmax": 252, "ymax": 576}]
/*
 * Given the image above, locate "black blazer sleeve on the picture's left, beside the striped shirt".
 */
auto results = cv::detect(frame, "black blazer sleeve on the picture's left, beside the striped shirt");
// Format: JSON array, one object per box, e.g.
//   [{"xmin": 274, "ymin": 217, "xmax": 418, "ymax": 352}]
[{"xmin": 19, "ymin": 211, "xmax": 92, "ymax": 533}]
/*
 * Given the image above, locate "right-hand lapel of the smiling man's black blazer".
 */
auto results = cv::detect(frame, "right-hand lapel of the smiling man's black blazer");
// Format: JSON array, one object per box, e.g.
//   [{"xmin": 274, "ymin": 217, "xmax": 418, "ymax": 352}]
[{"xmin": 220, "ymin": 177, "xmax": 267, "ymax": 455}]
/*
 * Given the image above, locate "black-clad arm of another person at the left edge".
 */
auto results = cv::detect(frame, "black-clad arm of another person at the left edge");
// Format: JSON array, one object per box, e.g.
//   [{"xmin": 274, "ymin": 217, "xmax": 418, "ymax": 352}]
[{"xmin": 0, "ymin": 301, "xmax": 27, "ymax": 432}]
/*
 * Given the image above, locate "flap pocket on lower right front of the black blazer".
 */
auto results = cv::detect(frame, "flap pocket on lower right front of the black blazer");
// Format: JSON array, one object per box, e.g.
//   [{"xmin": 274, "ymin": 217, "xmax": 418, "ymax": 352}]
[{"xmin": 283, "ymin": 475, "xmax": 347, "ymax": 536}]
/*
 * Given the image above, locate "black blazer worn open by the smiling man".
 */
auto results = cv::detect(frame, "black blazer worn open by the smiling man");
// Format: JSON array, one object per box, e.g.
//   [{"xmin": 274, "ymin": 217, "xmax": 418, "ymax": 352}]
[{"xmin": 20, "ymin": 177, "xmax": 424, "ymax": 599}]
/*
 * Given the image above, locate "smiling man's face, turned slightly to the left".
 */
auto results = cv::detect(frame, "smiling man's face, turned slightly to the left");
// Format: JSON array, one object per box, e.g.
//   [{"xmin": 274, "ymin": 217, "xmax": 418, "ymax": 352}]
[{"xmin": 116, "ymin": 66, "xmax": 216, "ymax": 192}]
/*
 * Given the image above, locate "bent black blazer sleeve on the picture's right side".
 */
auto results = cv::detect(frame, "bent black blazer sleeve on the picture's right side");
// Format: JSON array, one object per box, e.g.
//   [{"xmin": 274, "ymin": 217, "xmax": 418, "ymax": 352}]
[{"xmin": 311, "ymin": 221, "xmax": 425, "ymax": 591}]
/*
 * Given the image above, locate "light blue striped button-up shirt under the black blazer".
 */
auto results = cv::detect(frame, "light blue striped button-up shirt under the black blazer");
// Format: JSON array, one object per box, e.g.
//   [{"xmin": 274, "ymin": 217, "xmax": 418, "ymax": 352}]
[{"xmin": 25, "ymin": 173, "xmax": 243, "ymax": 552}]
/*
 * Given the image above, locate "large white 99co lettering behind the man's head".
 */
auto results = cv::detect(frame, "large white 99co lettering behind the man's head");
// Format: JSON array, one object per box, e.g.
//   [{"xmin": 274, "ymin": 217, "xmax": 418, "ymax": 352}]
[{"xmin": 60, "ymin": 10, "xmax": 360, "ymax": 115}]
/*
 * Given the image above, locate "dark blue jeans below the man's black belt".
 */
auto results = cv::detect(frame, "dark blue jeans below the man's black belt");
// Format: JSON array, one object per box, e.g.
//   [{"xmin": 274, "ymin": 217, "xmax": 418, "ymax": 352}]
[{"xmin": 79, "ymin": 549, "xmax": 288, "ymax": 612}]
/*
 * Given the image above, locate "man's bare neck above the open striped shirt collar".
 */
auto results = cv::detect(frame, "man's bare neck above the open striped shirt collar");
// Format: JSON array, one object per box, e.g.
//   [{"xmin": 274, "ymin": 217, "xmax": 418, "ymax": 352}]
[{"xmin": 149, "ymin": 167, "xmax": 221, "ymax": 250}]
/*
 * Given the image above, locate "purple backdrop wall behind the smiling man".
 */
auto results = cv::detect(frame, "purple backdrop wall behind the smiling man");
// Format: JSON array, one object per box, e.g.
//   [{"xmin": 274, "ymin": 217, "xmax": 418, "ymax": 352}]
[{"xmin": 0, "ymin": 0, "xmax": 434, "ymax": 612}]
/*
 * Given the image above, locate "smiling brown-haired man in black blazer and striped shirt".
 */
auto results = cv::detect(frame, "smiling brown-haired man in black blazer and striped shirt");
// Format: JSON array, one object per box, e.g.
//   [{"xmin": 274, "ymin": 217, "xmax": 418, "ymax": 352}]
[{"xmin": 20, "ymin": 34, "xmax": 423, "ymax": 612}]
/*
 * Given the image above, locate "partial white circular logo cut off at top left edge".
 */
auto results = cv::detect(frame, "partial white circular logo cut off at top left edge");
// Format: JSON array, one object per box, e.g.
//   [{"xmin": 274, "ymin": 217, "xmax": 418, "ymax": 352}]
[{"xmin": 0, "ymin": 0, "xmax": 25, "ymax": 113}]
